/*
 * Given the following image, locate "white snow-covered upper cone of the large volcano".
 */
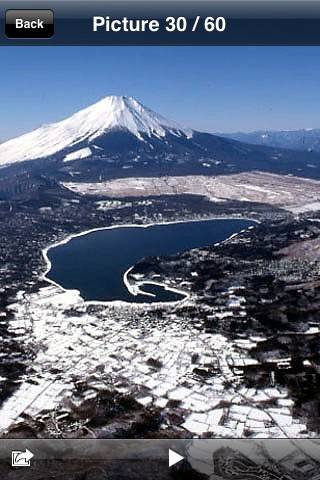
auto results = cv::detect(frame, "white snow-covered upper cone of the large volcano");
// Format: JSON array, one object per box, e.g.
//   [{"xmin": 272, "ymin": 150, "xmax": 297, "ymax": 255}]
[{"xmin": 0, "ymin": 96, "xmax": 193, "ymax": 165}]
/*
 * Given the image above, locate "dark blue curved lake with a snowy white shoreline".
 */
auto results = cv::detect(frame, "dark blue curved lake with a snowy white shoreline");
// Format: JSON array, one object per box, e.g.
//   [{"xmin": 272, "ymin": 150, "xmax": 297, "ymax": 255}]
[{"xmin": 47, "ymin": 219, "xmax": 254, "ymax": 303}]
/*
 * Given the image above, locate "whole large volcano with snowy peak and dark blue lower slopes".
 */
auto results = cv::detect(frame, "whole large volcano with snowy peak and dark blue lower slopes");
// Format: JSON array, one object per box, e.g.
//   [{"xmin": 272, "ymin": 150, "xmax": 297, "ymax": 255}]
[{"xmin": 0, "ymin": 96, "xmax": 320, "ymax": 181}]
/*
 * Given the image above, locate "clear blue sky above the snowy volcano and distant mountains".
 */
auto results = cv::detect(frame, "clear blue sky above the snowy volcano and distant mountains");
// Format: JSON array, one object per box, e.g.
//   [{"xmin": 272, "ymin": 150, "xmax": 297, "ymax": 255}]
[{"xmin": 0, "ymin": 47, "xmax": 320, "ymax": 141}]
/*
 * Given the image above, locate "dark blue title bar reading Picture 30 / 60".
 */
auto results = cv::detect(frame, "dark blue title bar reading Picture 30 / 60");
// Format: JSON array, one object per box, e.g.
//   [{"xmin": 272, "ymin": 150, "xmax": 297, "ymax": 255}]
[{"xmin": 0, "ymin": 0, "xmax": 320, "ymax": 45}]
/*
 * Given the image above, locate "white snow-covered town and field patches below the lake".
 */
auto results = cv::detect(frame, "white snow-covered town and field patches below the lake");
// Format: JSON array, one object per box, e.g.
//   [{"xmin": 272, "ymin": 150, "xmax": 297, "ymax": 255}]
[{"xmin": 0, "ymin": 287, "xmax": 307, "ymax": 437}]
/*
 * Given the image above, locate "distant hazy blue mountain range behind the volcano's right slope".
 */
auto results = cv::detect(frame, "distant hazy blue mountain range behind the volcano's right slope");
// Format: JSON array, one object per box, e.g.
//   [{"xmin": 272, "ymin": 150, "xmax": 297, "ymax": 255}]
[{"xmin": 222, "ymin": 128, "xmax": 320, "ymax": 152}]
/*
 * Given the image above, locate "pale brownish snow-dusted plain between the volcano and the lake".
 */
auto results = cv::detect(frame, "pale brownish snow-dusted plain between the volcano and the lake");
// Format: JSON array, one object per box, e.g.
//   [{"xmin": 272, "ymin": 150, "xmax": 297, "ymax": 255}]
[{"xmin": 64, "ymin": 172, "xmax": 320, "ymax": 213}]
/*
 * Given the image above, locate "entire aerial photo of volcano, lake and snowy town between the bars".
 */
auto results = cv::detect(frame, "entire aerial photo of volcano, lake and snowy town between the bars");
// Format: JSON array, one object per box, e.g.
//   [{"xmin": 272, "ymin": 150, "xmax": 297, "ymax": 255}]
[{"xmin": 0, "ymin": 47, "xmax": 320, "ymax": 442}]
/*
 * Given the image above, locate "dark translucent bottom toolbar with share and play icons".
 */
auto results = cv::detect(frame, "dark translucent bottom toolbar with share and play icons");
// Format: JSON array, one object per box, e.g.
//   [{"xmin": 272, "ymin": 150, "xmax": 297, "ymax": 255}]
[{"xmin": 0, "ymin": 439, "xmax": 320, "ymax": 480}]
